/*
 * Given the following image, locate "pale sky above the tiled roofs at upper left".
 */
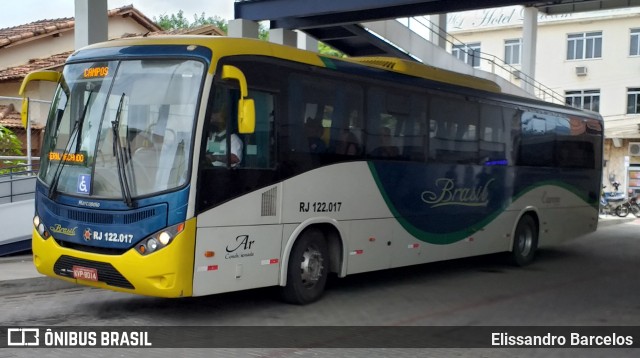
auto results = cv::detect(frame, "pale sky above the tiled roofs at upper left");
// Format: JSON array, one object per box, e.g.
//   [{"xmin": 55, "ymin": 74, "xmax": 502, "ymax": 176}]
[{"xmin": 0, "ymin": 0, "xmax": 234, "ymax": 29}]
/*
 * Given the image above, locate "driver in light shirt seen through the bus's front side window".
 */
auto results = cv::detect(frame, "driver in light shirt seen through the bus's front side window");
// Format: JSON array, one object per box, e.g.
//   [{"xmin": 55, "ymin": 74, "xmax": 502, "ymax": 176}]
[{"xmin": 206, "ymin": 108, "xmax": 243, "ymax": 168}]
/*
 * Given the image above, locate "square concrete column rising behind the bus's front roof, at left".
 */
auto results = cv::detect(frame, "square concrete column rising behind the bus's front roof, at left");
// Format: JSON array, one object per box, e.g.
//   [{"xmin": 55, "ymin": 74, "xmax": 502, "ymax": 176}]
[{"xmin": 74, "ymin": 0, "xmax": 109, "ymax": 49}]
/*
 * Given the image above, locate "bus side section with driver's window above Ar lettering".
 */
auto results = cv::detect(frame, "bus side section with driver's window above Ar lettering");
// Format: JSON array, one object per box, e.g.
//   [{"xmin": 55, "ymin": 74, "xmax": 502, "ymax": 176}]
[{"xmin": 193, "ymin": 84, "xmax": 282, "ymax": 295}]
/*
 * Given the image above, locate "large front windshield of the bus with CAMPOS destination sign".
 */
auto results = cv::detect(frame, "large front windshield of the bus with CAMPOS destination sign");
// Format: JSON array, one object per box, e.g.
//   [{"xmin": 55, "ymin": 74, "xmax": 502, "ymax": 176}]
[{"xmin": 39, "ymin": 59, "xmax": 205, "ymax": 200}]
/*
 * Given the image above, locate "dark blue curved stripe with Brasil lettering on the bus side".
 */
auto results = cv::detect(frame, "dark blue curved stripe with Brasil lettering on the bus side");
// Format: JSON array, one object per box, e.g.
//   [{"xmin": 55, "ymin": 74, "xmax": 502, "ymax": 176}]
[{"xmin": 369, "ymin": 162, "xmax": 599, "ymax": 245}]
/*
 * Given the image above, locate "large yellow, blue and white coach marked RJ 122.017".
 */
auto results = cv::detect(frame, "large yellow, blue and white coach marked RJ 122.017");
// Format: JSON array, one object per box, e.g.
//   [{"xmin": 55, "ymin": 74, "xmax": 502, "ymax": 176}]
[{"xmin": 21, "ymin": 37, "xmax": 603, "ymax": 304}]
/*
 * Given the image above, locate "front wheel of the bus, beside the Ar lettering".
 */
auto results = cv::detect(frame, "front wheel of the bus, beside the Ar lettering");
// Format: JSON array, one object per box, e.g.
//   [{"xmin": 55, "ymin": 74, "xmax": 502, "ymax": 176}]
[{"xmin": 282, "ymin": 229, "xmax": 329, "ymax": 304}]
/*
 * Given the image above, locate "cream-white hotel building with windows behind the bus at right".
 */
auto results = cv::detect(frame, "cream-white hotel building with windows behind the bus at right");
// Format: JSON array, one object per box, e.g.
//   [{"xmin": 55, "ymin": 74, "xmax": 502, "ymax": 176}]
[{"xmin": 447, "ymin": 6, "xmax": 640, "ymax": 193}]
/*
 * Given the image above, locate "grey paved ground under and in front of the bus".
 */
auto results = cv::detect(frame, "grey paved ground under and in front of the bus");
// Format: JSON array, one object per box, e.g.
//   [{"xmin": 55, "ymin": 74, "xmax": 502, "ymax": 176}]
[{"xmin": 0, "ymin": 217, "xmax": 640, "ymax": 358}]
